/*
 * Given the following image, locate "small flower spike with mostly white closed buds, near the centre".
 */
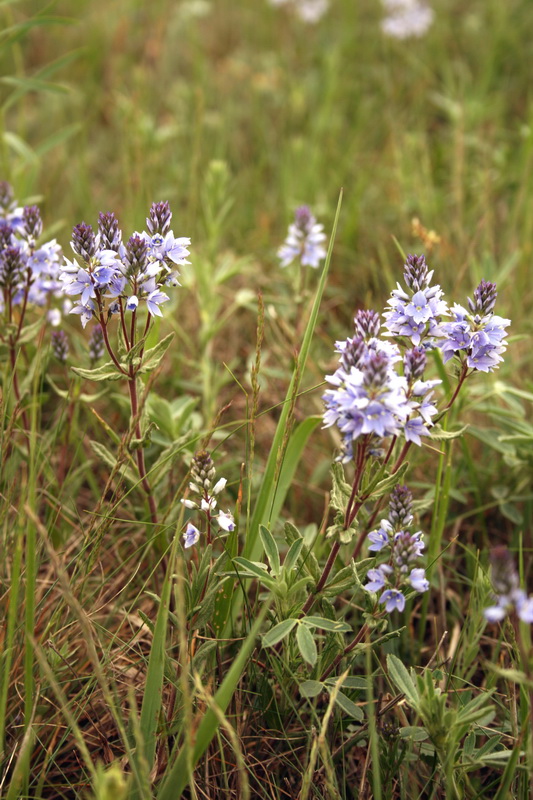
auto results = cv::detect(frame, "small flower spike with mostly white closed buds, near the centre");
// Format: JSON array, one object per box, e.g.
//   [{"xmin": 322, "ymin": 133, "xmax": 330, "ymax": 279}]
[{"xmin": 181, "ymin": 450, "xmax": 235, "ymax": 548}]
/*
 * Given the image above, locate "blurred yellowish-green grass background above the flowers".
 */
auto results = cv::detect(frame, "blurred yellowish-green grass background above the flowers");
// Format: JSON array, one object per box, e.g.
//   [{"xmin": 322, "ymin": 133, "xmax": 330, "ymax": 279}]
[{"xmin": 2, "ymin": 0, "xmax": 533, "ymax": 340}]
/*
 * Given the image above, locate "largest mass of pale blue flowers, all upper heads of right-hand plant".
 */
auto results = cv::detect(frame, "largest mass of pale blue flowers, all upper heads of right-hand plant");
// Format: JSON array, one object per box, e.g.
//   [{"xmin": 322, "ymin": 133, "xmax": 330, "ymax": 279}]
[{"xmin": 323, "ymin": 255, "xmax": 510, "ymax": 461}]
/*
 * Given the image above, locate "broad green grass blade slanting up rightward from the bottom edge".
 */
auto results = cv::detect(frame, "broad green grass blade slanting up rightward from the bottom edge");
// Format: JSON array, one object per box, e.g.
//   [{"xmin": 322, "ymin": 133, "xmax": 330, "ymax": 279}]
[{"xmin": 157, "ymin": 601, "xmax": 270, "ymax": 800}]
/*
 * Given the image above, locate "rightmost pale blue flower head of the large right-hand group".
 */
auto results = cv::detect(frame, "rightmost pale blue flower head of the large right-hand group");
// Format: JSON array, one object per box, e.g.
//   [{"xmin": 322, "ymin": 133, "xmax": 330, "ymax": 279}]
[{"xmin": 439, "ymin": 281, "xmax": 511, "ymax": 372}]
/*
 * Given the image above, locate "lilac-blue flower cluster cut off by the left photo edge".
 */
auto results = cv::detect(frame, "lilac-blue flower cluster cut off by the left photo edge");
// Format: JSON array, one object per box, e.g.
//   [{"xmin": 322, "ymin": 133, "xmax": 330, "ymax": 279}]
[{"xmin": 0, "ymin": 181, "xmax": 62, "ymax": 324}]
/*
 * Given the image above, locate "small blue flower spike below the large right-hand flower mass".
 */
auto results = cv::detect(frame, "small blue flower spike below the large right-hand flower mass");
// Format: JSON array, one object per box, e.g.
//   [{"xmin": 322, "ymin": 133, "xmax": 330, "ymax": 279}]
[{"xmin": 363, "ymin": 485, "xmax": 429, "ymax": 613}]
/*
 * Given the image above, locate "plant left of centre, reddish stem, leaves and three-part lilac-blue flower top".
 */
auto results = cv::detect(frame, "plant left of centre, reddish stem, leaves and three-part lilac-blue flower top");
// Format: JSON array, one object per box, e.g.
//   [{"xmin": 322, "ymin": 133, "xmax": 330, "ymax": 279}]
[{"xmin": 59, "ymin": 202, "xmax": 190, "ymax": 524}]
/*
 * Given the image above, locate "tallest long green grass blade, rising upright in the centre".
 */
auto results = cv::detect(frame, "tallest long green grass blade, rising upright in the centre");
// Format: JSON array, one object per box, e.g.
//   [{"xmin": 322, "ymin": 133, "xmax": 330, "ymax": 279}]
[{"xmin": 243, "ymin": 190, "xmax": 342, "ymax": 561}]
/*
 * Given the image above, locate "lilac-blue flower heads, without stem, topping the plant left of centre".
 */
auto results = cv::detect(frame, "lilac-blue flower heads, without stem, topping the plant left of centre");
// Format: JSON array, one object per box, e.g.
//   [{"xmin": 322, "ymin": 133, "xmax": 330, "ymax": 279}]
[{"xmin": 60, "ymin": 202, "xmax": 190, "ymax": 327}]
